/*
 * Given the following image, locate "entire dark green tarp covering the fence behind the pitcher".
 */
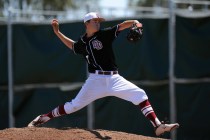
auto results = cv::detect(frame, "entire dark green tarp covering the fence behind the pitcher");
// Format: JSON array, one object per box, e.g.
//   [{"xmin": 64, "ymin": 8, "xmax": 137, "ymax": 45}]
[{"xmin": 0, "ymin": 17, "xmax": 210, "ymax": 140}]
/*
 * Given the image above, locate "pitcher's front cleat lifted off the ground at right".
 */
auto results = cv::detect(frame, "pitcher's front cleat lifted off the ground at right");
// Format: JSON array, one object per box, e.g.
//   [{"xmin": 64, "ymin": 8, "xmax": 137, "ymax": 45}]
[{"xmin": 155, "ymin": 123, "xmax": 179, "ymax": 136}]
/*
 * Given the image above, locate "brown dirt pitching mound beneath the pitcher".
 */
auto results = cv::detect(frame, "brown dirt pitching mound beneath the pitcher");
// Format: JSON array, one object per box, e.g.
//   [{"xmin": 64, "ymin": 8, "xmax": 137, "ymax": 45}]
[{"xmin": 0, "ymin": 127, "xmax": 167, "ymax": 140}]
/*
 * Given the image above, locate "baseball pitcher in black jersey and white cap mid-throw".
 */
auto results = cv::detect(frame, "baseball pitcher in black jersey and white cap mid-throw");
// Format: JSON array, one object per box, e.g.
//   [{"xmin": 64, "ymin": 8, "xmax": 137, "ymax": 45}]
[{"xmin": 28, "ymin": 12, "xmax": 179, "ymax": 136}]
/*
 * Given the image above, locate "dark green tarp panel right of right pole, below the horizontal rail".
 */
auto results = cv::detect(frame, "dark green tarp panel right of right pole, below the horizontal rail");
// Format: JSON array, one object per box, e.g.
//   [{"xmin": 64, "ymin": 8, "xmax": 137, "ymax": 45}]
[{"xmin": 176, "ymin": 83, "xmax": 210, "ymax": 140}]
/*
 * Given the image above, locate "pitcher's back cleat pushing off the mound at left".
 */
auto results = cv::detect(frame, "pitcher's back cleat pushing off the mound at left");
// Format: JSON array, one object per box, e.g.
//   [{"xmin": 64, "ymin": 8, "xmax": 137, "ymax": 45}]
[{"xmin": 28, "ymin": 115, "xmax": 50, "ymax": 127}]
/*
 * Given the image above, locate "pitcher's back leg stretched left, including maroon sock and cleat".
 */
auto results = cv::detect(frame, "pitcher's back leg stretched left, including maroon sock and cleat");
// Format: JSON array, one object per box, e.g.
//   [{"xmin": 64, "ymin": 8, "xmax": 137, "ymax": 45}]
[{"xmin": 28, "ymin": 74, "xmax": 105, "ymax": 127}]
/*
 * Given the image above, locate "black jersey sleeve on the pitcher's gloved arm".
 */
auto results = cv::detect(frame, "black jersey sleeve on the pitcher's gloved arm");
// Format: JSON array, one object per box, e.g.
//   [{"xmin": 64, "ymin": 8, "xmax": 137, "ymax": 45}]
[{"xmin": 104, "ymin": 25, "xmax": 120, "ymax": 40}]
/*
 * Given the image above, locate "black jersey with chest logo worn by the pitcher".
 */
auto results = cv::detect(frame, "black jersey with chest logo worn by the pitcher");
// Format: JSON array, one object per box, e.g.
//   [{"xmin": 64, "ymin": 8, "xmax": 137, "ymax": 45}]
[{"xmin": 73, "ymin": 25, "xmax": 119, "ymax": 73}]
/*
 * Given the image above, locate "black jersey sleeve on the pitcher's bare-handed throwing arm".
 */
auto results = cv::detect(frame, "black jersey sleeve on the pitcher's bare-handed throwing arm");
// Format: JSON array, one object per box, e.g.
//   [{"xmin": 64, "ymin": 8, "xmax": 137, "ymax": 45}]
[{"xmin": 72, "ymin": 39, "xmax": 86, "ymax": 54}]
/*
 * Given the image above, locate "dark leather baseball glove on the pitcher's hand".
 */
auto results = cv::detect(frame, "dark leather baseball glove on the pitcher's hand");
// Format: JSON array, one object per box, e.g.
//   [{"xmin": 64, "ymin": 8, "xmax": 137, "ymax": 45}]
[{"xmin": 127, "ymin": 24, "xmax": 143, "ymax": 43}]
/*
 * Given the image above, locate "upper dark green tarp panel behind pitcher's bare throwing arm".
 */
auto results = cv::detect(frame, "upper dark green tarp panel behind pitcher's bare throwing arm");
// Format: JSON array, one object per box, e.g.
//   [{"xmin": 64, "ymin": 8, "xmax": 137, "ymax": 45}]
[{"xmin": 13, "ymin": 24, "xmax": 85, "ymax": 84}]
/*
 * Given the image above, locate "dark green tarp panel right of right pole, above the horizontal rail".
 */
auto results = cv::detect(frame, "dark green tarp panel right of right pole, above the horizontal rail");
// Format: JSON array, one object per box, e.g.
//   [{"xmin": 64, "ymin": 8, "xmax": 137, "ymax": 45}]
[{"xmin": 175, "ymin": 17, "xmax": 210, "ymax": 78}]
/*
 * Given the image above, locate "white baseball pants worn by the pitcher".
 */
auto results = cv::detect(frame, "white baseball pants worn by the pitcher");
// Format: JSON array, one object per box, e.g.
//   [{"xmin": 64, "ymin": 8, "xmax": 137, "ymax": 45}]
[{"xmin": 64, "ymin": 74, "xmax": 148, "ymax": 114}]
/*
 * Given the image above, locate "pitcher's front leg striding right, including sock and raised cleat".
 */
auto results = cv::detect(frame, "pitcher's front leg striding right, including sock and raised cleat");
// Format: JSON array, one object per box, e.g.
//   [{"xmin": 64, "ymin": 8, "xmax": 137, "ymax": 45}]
[{"xmin": 111, "ymin": 76, "xmax": 179, "ymax": 136}]
